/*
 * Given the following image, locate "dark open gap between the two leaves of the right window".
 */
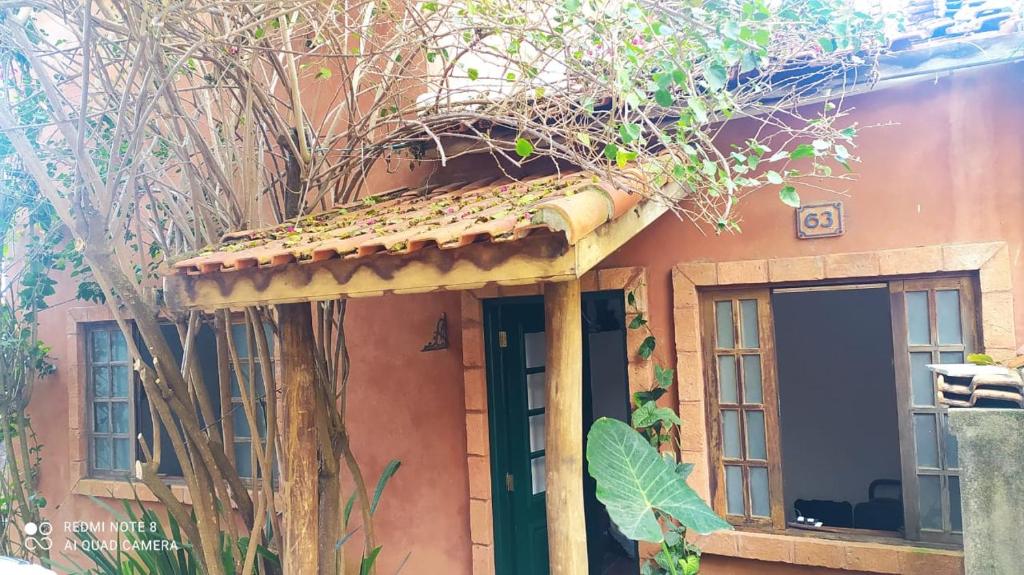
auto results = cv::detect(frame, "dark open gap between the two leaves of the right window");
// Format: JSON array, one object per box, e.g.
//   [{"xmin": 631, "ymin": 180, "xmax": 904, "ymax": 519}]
[{"xmin": 772, "ymin": 284, "xmax": 903, "ymax": 531}]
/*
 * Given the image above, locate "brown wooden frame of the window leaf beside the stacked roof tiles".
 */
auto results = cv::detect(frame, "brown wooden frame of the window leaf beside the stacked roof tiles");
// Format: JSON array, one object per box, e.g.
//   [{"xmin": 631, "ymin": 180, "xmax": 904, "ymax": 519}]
[{"xmin": 889, "ymin": 275, "xmax": 980, "ymax": 543}]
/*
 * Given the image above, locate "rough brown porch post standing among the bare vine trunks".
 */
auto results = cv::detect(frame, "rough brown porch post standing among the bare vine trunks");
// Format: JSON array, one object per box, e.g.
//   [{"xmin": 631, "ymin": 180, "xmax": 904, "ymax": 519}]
[{"xmin": 278, "ymin": 303, "xmax": 319, "ymax": 575}]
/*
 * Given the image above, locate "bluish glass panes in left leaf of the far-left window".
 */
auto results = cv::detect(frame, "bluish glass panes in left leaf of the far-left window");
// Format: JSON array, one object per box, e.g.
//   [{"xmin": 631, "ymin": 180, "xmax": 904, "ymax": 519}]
[{"xmin": 86, "ymin": 325, "xmax": 135, "ymax": 475}]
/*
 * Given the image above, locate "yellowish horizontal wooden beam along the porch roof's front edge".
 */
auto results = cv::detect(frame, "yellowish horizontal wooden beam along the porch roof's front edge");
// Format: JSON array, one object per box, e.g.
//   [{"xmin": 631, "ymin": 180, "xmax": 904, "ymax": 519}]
[{"xmin": 164, "ymin": 232, "xmax": 577, "ymax": 310}]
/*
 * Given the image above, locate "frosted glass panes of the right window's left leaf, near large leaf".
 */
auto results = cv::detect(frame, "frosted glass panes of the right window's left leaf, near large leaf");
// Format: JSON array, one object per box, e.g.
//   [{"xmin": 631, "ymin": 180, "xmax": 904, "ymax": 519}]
[{"xmin": 703, "ymin": 292, "xmax": 781, "ymax": 527}]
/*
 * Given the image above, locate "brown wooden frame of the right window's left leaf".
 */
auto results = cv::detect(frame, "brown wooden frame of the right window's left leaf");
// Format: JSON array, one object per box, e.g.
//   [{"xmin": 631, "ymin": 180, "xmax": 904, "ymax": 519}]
[{"xmin": 700, "ymin": 288, "xmax": 785, "ymax": 530}]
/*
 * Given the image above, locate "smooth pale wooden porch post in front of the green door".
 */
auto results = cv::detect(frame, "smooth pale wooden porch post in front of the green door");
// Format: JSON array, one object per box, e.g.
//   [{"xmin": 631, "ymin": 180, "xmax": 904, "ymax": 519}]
[{"xmin": 544, "ymin": 279, "xmax": 589, "ymax": 575}]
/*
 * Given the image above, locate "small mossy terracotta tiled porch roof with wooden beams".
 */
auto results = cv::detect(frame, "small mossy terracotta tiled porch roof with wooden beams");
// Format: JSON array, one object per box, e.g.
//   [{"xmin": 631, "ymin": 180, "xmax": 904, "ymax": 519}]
[{"xmin": 164, "ymin": 172, "xmax": 674, "ymax": 309}]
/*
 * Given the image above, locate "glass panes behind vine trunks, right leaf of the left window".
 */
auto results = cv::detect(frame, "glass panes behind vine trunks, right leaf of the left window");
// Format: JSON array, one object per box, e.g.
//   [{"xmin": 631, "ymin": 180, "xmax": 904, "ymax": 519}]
[{"xmin": 228, "ymin": 322, "xmax": 273, "ymax": 478}]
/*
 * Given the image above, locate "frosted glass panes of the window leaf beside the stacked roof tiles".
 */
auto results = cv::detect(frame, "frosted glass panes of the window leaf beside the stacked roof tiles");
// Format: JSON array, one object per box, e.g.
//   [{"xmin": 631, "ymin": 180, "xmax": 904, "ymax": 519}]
[{"xmin": 896, "ymin": 278, "xmax": 975, "ymax": 540}]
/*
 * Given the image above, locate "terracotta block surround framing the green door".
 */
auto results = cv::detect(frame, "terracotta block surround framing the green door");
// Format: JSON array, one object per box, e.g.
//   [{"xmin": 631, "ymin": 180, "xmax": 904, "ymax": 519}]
[{"xmin": 462, "ymin": 267, "xmax": 654, "ymax": 575}]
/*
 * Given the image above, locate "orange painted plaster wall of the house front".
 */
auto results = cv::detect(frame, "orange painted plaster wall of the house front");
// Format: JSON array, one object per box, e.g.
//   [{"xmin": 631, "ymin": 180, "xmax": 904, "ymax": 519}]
[{"xmin": 24, "ymin": 59, "xmax": 1024, "ymax": 575}]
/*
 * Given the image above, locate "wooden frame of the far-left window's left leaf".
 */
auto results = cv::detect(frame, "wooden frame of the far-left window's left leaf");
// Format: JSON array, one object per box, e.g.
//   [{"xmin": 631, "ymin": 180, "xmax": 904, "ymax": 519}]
[{"xmin": 83, "ymin": 321, "xmax": 138, "ymax": 479}]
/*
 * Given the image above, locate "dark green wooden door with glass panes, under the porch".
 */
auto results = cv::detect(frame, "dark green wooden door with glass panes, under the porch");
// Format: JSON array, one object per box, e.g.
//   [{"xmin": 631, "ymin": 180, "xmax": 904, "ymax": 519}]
[{"xmin": 484, "ymin": 298, "xmax": 548, "ymax": 575}]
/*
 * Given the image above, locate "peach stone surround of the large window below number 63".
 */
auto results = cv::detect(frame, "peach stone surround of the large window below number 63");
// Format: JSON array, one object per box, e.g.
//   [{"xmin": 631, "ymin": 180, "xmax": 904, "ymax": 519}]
[{"xmin": 672, "ymin": 241, "xmax": 1017, "ymax": 575}]
